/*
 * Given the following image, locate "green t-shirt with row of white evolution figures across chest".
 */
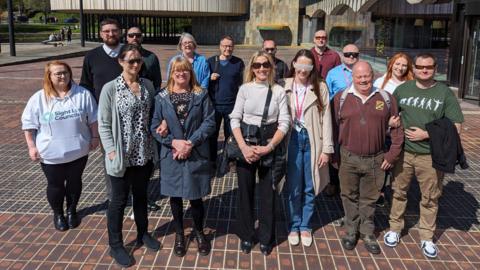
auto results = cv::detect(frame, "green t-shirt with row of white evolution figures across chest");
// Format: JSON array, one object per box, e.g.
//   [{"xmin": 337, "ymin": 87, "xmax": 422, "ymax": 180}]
[{"xmin": 393, "ymin": 80, "xmax": 464, "ymax": 154}]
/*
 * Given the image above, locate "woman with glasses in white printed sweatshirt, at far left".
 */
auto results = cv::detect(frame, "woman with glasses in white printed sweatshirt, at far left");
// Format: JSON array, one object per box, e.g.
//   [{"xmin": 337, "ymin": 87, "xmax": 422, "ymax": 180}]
[{"xmin": 22, "ymin": 61, "xmax": 99, "ymax": 231}]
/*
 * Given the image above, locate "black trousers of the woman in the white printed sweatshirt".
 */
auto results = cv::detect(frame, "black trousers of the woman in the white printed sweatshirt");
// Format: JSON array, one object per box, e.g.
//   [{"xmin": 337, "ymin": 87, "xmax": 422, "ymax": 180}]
[{"xmin": 40, "ymin": 155, "xmax": 88, "ymax": 214}]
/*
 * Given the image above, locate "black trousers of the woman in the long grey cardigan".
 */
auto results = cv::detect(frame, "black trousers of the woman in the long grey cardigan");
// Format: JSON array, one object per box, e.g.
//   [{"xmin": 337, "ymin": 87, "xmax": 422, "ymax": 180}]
[{"xmin": 107, "ymin": 161, "xmax": 153, "ymax": 247}]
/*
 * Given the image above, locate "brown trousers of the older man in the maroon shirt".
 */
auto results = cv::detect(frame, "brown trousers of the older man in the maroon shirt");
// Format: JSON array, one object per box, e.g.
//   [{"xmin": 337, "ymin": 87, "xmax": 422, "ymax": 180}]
[{"xmin": 339, "ymin": 148, "xmax": 385, "ymax": 235}]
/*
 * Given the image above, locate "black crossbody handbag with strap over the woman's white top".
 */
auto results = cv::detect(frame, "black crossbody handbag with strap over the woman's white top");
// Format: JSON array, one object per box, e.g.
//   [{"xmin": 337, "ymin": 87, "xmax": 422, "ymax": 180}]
[{"xmin": 224, "ymin": 86, "xmax": 276, "ymax": 162}]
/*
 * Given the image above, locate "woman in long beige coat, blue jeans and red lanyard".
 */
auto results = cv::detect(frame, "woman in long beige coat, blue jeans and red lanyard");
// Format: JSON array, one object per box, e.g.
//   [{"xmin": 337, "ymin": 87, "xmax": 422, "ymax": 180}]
[{"xmin": 285, "ymin": 49, "xmax": 334, "ymax": 246}]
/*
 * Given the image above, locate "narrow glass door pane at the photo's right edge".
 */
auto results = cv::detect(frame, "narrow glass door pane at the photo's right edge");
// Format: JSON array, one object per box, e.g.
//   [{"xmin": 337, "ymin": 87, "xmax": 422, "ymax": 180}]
[{"xmin": 465, "ymin": 18, "xmax": 480, "ymax": 100}]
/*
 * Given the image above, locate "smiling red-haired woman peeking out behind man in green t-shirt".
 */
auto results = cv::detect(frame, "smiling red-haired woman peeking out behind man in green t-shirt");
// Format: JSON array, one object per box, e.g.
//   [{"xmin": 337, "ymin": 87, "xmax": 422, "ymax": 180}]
[{"xmin": 373, "ymin": 52, "xmax": 413, "ymax": 94}]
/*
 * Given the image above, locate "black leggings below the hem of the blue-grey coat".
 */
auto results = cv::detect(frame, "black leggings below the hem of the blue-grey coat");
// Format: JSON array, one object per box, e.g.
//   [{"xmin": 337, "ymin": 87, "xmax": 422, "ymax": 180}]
[{"xmin": 170, "ymin": 197, "xmax": 204, "ymax": 234}]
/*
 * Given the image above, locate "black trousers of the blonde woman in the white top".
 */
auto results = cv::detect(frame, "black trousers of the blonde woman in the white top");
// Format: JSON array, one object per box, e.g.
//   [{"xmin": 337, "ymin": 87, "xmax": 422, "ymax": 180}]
[{"xmin": 236, "ymin": 161, "xmax": 275, "ymax": 245}]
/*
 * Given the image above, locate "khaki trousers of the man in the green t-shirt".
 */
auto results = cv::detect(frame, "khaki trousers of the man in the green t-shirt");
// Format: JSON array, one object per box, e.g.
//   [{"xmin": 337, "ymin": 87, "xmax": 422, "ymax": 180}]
[{"xmin": 390, "ymin": 152, "xmax": 444, "ymax": 241}]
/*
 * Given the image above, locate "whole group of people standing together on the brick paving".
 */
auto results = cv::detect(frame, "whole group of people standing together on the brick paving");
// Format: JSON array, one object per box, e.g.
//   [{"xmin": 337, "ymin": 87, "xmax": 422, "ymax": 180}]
[{"xmin": 22, "ymin": 19, "xmax": 463, "ymax": 266}]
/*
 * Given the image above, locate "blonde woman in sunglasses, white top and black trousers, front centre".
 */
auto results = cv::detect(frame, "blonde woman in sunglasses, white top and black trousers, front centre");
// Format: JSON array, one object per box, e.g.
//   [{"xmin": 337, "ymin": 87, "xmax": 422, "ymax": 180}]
[{"xmin": 230, "ymin": 51, "xmax": 290, "ymax": 255}]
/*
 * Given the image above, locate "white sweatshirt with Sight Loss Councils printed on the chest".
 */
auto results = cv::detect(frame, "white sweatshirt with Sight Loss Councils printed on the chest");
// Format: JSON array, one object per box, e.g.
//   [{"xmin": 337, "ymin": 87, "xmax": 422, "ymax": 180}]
[{"xmin": 22, "ymin": 83, "xmax": 97, "ymax": 164}]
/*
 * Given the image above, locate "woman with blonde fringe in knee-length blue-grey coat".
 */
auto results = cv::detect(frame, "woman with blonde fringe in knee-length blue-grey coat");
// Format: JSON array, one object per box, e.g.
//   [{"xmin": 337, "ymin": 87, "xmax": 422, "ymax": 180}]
[{"xmin": 151, "ymin": 58, "xmax": 215, "ymax": 257}]
